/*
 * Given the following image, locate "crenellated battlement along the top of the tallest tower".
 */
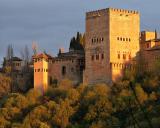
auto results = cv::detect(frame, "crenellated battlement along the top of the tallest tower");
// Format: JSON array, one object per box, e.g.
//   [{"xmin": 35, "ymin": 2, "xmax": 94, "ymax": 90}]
[{"xmin": 86, "ymin": 8, "xmax": 139, "ymax": 18}]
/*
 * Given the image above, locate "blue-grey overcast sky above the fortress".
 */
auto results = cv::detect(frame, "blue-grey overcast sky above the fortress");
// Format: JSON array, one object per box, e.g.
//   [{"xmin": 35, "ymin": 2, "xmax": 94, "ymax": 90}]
[{"xmin": 0, "ymin": 0, "xmax": 160, "ymax": 60}]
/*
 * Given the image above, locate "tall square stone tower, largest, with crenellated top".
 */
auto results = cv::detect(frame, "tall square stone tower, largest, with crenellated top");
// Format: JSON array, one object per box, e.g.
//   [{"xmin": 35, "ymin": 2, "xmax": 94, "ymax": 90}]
[{"xmin": 83, "ymin": 8, "xmax": 140, "ymax": 84}]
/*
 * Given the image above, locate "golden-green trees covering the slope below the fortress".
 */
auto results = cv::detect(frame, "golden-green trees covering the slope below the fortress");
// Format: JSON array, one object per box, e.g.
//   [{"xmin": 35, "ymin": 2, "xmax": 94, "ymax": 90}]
[{"xmin": 0, "ymin": 72, "xmax": 160, "ymax": 128}]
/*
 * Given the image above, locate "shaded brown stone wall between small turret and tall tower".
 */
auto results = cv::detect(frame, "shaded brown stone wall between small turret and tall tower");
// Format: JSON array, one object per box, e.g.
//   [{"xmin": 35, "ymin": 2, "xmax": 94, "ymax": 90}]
[{"xmin": 49, "ymin": 57, "xmax": 84, "ymax": 84}]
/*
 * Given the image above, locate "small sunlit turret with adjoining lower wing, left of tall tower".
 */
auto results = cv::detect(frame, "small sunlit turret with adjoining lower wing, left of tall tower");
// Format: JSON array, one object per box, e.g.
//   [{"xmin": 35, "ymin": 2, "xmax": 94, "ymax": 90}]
[{"xmin": 33, "ymin": 51, "xmax": 84, "ymax": 93}]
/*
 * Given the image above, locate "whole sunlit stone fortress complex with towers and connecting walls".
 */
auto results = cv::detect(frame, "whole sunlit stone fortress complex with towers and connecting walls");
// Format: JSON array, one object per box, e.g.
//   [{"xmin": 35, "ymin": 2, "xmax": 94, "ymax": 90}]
[{"xmin": 33, "ymin": 8, "xmax": 160, "ymax": 91}]
